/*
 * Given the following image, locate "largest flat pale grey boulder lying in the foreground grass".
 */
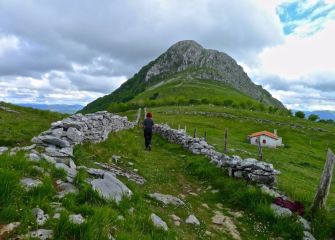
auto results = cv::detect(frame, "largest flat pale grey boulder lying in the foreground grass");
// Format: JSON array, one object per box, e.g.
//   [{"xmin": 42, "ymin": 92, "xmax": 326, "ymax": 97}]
[{"xmin": 91, "ymin": 172, "xmax": 132, "ymax": 203}]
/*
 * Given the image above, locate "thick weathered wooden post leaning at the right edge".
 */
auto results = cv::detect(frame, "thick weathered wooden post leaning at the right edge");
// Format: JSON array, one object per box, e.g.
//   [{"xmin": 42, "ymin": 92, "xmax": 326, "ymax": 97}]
[{"xmin": 311, "ymin": 148, "xmax": 335, "ymax": 213}]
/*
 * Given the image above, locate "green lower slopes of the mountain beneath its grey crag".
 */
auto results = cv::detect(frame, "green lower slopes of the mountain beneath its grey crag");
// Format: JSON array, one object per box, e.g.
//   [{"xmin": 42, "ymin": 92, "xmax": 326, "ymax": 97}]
[{"xmin": 80, "ymin": 65, "xmax": 284, "ymax": 113}]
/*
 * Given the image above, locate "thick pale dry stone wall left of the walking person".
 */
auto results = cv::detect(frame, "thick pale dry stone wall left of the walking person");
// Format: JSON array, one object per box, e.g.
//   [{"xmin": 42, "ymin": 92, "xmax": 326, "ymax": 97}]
[{"xmin": 29, "ymin": 111, "xmax": 140, "ymax": 182}]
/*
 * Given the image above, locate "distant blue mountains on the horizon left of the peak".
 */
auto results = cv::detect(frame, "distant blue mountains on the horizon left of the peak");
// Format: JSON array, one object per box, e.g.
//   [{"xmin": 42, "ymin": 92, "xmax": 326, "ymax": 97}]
[{"xmin": 18, "ymin": 103, "xmax": 83, "ymax": 114}]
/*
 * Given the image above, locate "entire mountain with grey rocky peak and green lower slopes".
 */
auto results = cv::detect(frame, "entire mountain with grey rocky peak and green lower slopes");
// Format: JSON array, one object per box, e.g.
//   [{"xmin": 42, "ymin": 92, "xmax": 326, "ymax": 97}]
[{"xmin": 82, "ymin": 40, "xmax": 285, "ymax": 113}]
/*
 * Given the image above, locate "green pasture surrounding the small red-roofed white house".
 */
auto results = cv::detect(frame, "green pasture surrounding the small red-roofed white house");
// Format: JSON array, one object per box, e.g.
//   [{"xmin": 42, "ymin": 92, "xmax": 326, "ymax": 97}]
[{"xmin": 142, "ymin": 105, "xmax": 335, "ymax": 208}]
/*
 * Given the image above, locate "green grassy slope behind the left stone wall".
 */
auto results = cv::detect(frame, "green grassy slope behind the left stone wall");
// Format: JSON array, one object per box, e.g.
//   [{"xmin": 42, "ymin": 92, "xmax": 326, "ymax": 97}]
[{"xmin": 0, "ymin": 102, "xmax": 65, "ymax": 147}]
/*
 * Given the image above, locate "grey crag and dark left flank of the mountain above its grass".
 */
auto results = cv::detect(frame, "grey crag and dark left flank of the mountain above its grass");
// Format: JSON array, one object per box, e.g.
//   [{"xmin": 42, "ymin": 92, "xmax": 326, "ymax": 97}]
[{"xmin": 82, "ymin": 40, "xmax": 285, "ymax": 112}]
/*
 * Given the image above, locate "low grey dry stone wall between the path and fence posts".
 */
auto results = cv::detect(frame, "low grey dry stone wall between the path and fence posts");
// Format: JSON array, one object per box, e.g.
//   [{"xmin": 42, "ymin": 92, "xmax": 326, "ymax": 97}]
[{"xmin": 154, "ymin": 124, "xmax": 280, "ymax": 186}]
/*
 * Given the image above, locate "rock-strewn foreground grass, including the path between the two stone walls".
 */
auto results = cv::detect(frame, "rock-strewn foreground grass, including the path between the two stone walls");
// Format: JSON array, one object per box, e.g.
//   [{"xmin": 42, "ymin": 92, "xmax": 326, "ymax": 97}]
[{"xmin": 0, "ymin": 126, "xmax": 308, "ymax": 240}]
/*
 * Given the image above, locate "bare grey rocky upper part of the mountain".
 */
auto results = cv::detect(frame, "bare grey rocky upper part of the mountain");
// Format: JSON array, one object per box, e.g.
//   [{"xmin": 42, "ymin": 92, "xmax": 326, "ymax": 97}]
[{"xmin": 145, "ymin": 40, "xmax": 284, "ymax": 108}]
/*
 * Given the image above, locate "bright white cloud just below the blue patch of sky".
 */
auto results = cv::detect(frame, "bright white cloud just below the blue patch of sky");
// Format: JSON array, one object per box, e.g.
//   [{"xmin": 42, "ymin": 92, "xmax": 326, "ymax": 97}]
[{"xmin": 260, "ymin": 21, "xmax": 335, "ymax": 79}]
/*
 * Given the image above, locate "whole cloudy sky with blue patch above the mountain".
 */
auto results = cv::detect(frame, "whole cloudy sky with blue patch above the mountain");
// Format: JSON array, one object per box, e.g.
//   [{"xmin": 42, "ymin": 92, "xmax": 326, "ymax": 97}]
[{"xmin": 0, "ymin": 0, "xmax": 335, "ymax": 110}]
